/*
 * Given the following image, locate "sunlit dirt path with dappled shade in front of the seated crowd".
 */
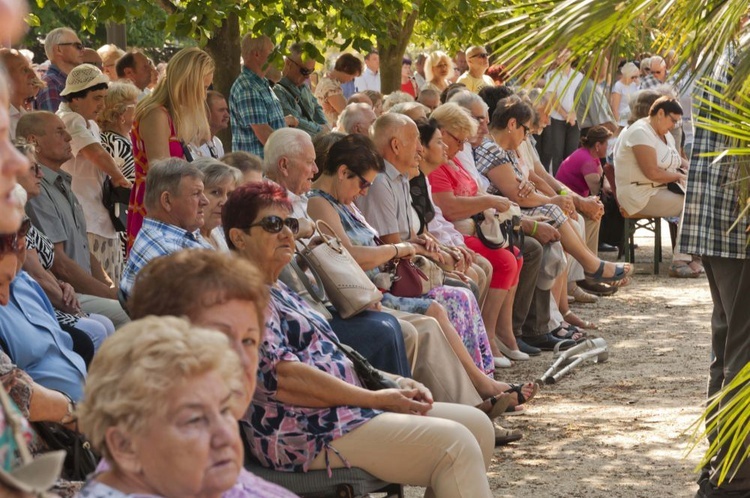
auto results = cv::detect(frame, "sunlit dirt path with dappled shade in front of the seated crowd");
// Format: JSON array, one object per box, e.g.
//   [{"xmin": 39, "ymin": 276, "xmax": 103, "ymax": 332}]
[{"xmin": 407, "ymin": 230, "xmax": 711, "ymax": 498}]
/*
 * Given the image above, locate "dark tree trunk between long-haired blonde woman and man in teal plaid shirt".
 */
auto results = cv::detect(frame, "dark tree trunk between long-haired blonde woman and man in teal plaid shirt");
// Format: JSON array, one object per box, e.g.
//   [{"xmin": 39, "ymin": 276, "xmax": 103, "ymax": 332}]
[{"xmin": 206, "ymin": 12, "xmax": 241, "ymax": 152}]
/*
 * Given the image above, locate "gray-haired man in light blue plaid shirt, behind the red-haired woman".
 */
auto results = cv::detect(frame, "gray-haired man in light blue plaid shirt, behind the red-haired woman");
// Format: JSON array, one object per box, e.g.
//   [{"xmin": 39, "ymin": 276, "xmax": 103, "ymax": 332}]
[{"xmin": 120, "ymin": 157, "xmax": 213, "ymax": 300}]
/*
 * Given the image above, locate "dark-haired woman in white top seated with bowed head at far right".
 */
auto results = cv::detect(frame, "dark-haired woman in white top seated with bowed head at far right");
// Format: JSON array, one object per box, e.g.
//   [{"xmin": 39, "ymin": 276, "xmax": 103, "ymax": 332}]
[{"xmin": 615, "ymin": 97, "xmax": 699, "ymax": 278}]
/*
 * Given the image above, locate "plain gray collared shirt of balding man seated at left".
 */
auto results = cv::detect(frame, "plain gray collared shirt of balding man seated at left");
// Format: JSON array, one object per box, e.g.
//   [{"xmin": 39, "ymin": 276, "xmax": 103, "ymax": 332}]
[{"xmin": 26, "ymin": 165, "xmax": 91, "ymax": 274}]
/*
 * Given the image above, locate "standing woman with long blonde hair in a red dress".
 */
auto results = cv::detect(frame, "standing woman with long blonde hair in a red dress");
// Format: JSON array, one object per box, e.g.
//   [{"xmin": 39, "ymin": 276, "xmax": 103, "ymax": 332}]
[{"xmin": 128, "ymin": 47, "xmax": 215, "ymax": 250}]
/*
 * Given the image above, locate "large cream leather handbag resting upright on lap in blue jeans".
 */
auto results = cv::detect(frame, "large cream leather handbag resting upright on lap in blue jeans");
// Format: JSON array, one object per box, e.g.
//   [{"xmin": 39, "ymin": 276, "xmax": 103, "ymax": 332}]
[{"xmin": 297, "ymin": 220, "xmax": 383, "ymax": 318}]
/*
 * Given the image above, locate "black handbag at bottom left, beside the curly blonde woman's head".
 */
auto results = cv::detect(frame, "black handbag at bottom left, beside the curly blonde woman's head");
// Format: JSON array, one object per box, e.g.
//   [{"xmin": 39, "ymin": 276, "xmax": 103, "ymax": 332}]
[{"xmin": 32, "ymin": 422, "xmax": 100, "ymax": 481}]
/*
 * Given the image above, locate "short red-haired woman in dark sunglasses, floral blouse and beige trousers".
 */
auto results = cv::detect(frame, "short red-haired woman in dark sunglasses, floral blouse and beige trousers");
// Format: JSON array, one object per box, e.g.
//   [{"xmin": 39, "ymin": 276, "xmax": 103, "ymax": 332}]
[{"xmin": 222, "ymin": 182, "xmax": 494, "ymax": 497}]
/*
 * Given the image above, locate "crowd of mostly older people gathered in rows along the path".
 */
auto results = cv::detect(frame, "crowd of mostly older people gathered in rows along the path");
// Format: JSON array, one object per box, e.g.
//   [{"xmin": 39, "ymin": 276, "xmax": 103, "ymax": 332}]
[{"xmin": 0, "ymin": 21, "xmax": 712, "ymax": 498}]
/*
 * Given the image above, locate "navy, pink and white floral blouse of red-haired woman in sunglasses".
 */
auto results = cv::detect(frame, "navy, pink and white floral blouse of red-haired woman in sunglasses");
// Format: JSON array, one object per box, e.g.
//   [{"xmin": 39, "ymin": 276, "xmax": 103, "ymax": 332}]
[{"xmin": 241, "ymin": 282, "xmax": 381, "ymax": 472}]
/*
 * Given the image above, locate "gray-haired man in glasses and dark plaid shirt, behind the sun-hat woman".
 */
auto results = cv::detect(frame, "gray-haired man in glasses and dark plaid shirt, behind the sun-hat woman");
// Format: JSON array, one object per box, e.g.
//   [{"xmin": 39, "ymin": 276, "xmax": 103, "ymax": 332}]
[{"xmin": 34, "ymin": 28, "xmax": 84, "ymax": 112}]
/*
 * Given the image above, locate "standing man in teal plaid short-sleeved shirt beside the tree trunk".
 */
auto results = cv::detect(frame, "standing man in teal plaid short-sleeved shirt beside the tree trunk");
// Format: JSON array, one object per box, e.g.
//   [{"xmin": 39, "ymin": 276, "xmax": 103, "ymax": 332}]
[{"xmin": 229, "ymin": 34, "xmax": 299, "ymax": 157}]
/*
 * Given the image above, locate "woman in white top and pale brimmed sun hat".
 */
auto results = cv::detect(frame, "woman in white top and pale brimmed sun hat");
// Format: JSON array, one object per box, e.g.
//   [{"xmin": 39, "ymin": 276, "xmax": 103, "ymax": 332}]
[{"xmin": 57, "ymin": 64, "xmax": 132, "ymax": 285}]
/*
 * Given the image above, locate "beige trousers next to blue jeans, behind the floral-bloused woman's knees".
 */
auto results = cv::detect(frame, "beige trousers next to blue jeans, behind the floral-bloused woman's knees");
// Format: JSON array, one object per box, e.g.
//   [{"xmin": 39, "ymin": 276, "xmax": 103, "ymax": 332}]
[{"xmin": 383, "ymin": 307, "xmax": 482, "ymax": 406}]
